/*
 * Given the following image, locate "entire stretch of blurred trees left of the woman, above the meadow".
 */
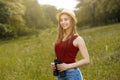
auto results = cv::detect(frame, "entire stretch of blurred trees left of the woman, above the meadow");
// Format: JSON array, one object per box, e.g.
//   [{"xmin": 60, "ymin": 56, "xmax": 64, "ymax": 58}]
[{"xmin": 0, "ymin": 0, "xmax": 57, "ymax": 38}]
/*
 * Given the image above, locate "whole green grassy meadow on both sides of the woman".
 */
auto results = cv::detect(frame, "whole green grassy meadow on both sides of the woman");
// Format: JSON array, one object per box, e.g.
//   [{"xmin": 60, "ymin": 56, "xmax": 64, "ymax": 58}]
[{"xmin": 0, "ymin": 24, "xmax": 120, "ymax": 80}]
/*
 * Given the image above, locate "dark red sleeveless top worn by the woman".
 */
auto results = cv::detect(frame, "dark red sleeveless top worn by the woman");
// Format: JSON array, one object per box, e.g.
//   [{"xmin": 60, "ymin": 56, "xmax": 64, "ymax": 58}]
[{"xmin": 55, "ymin": 35, "xmax": 79, "ymax": 63}]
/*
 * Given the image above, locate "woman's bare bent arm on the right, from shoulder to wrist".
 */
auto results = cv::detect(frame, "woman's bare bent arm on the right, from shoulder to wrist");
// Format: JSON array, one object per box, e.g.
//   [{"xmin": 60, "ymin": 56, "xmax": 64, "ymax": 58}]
[{"xmin": 69, "ymin": 36, "xmax": 90, "ymax": 68}]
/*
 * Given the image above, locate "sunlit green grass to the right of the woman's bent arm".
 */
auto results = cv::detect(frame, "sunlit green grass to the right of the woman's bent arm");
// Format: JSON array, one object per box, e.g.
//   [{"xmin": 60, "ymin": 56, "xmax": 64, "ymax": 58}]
[{"xmin": 81, "ymin": 24, "xmax": 120, "ymax": 80}]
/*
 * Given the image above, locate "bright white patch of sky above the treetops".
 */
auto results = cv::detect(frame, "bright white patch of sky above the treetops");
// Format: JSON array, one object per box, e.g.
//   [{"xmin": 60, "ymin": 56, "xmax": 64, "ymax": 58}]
[{"xmin": 38, "ymin": 0, "xmax": 78, "ymax": 10}]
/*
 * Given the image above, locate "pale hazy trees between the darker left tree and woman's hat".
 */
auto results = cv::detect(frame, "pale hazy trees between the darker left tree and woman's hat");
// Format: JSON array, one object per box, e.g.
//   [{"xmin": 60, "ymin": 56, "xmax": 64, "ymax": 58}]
[{"xmin": 24, "ymin": 0, "xmax": 57, "ymax": 29}]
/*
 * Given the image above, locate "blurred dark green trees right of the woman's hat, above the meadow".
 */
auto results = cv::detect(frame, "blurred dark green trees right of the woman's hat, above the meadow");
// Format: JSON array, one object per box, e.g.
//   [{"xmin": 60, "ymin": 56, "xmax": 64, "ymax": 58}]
[{"xmin": 76, "ymin": 0, "xmax": 120, "ymax": 26}]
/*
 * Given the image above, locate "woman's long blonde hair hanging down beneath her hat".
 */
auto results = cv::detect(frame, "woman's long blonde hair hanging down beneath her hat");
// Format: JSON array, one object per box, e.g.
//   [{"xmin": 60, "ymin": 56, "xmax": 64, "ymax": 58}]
[{"xmin": 56, "ymin": 13, "xmax": 78, "ymax": 43}]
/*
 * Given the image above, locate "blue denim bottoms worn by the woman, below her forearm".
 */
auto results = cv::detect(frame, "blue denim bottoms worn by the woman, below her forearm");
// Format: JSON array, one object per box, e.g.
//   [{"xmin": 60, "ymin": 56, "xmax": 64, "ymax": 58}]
[{"xmin": 58, "ymin": 68, "xmax": 83, "ymax": 80}]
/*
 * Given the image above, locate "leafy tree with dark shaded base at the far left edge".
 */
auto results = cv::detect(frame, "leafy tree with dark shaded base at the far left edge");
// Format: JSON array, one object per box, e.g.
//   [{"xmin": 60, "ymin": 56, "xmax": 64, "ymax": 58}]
[{"xmin": 0, "ymin": 0, "xmax": 25, "ymax": 36}]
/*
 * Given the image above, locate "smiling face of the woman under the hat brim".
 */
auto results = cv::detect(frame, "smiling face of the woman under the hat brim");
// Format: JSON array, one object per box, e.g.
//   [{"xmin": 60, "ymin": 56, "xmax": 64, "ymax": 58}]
[{"xmin": 60, "ymin": 14, "xmax": 71, "ymax": 30}]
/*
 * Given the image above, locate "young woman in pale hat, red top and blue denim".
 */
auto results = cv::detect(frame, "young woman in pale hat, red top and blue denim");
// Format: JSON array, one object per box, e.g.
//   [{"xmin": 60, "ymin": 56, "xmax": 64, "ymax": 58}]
[{"xmin": 51, "ymin": 9, "xmax": 90, "ymax": 80}]
